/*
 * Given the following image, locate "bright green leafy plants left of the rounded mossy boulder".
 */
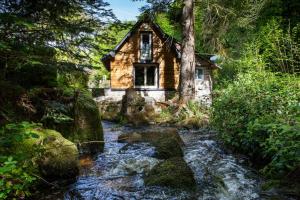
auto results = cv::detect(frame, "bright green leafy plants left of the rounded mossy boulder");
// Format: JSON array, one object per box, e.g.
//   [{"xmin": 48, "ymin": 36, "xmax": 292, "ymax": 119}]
[{"xmin": 0, "ymin": 122, "xmax": 40, "ymax": 199}]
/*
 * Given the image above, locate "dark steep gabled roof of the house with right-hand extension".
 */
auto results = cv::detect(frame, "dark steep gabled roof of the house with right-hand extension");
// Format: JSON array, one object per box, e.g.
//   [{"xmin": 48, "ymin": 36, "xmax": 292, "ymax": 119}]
[{"xmin": 101, "ymin": 19, "xmax": 217, "ymax": 69}]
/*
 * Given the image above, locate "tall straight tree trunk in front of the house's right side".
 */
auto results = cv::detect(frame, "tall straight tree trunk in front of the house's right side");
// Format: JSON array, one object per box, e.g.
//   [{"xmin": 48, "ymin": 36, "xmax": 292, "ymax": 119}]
[{"xmin": 179, "ymin": 0, "xmax": 195, "ymax": 103}]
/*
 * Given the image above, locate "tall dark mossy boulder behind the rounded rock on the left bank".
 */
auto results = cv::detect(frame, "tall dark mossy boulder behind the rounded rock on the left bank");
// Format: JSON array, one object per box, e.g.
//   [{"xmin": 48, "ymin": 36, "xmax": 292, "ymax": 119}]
[{"xmin": 33, "ymin": 89, "xmax": 104, "ymax": 154}]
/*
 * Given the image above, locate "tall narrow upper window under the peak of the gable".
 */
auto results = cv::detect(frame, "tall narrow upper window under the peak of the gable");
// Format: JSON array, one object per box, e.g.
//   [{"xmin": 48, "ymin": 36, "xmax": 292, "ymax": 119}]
[{"xmin": 140, "ymin": 32, "xmax": 152, "ymax": 62}]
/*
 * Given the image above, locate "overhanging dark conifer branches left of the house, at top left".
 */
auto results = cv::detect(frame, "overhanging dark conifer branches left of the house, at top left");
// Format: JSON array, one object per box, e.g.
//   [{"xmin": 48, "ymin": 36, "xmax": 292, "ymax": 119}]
[{"xmin": 0, "ymin": 0, "xmax": 115, "ymax": 88}]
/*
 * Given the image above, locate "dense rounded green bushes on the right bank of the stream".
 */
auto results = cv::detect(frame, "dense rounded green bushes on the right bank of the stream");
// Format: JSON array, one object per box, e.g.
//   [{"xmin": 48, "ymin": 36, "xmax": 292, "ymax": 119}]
[{"xmin": 212, "ymin": 71, "xmax": 300, "ymax": 177}]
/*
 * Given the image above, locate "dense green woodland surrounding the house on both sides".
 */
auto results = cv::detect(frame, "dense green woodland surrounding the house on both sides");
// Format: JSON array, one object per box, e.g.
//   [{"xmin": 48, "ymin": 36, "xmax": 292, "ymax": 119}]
[{"xmin": 0, "ymin": 0, "xmax": 300, "ymax": 199}]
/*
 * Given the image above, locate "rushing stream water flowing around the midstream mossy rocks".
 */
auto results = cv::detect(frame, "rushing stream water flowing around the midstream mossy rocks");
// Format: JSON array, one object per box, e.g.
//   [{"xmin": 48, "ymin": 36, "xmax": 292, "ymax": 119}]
[{"xmin": 35, "ymin": 122, "xmax": 296, "ymax": 200}]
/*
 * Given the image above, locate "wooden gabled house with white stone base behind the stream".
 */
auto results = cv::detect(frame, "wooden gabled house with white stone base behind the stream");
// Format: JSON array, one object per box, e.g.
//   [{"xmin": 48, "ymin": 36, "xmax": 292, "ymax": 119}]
[{"xmin": 102, "ymin": 20, "xmax": 216, "ymax": 102}]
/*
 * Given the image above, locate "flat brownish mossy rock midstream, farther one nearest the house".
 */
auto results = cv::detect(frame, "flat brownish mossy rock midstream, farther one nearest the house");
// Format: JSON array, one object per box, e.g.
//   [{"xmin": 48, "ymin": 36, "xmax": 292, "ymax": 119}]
[{"xmin": 118, "ymin": 127, "xmax": 183, "ymax": 159}]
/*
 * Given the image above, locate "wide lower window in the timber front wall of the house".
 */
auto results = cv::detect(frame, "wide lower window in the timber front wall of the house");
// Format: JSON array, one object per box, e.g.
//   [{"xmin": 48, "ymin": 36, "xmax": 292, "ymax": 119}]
[{"xmin": 134, "ymin": 65, "xmax": 158, "ymax": 88}]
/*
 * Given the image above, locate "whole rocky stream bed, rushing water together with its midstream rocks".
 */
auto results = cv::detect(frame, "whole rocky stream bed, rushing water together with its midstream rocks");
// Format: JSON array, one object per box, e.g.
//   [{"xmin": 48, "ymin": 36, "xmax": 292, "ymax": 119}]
[{"xmin": 34, "ymin": 122, "xmax": 296, "ymax": 200}]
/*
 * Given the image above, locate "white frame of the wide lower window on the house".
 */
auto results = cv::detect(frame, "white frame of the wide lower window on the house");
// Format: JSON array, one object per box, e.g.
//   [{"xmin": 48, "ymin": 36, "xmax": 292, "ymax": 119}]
[{"xmin": 133, "ymin": 64, "xmax": 158, "ymax": 89}]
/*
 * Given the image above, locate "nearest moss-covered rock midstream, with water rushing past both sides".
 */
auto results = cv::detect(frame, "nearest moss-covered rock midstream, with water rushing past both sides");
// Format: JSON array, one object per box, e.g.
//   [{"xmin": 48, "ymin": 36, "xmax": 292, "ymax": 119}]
[{"xmin": 144, "ymin": 157, "xmax": 196, "ymax": 189}]
